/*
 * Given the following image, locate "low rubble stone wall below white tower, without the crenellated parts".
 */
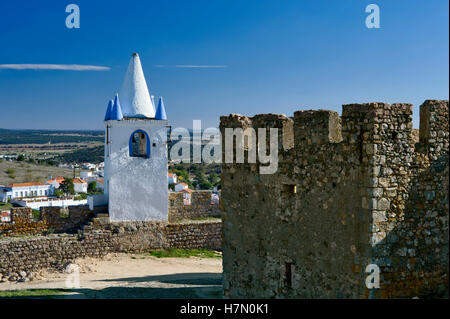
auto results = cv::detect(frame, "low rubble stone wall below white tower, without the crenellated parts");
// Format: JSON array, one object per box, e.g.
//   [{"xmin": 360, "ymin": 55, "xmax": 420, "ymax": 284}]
[{"xmin": 0, "ymin": 221, "xmax": 222, "ymax": 278}]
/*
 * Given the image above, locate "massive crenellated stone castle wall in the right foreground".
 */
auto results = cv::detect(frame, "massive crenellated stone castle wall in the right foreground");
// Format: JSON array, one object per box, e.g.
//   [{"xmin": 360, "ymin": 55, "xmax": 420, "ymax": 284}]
[{"xmin": 220, "ymin": 101, "xmax": 449, "ymax": 298}]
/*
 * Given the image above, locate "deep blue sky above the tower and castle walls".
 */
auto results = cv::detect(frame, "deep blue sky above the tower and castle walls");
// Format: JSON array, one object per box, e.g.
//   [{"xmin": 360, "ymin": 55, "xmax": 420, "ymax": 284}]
[{"xmin": 0, "ymin": 0, "xmax": 449, "ymax": 129}]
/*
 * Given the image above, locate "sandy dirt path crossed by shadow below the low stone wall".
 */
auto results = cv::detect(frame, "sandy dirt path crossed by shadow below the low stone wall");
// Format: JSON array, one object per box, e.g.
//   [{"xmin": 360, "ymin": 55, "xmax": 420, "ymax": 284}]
[{"xmin": 0, "ymin": 253, "xmax": 222, "ymax": 298}]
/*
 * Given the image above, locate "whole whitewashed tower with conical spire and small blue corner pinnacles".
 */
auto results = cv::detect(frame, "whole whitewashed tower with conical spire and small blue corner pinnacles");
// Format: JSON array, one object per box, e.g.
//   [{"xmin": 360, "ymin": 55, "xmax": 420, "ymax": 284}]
[{"xmin": 105, "ymin": 53, "xmax": 168, "ymax": 221}]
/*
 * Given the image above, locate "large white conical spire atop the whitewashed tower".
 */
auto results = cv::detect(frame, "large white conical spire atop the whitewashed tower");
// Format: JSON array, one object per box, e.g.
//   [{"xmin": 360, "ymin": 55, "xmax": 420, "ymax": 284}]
[{"xmin": 119, "ymin": 53, "xmax": 155, "ymax": 117}]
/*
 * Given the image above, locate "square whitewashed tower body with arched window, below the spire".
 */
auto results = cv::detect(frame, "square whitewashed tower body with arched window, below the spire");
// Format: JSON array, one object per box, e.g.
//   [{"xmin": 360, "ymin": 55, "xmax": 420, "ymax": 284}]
[{"xmin": 104, "ymin": 119, "xmax": 168, "ymax": 221}]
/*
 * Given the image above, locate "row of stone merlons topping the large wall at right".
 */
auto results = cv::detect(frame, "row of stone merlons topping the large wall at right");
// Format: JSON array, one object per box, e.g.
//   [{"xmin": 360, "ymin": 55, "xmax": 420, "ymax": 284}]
[{"xmin": 220, "ymin": 100, "xmax": 449, "ymax": 158}]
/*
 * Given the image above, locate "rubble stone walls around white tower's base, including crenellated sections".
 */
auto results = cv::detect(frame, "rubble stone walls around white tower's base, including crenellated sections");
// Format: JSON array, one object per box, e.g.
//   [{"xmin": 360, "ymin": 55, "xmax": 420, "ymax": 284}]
[{"xmin": 0, "ymin": 191, "xmax": 222, "ymax": 279}]
